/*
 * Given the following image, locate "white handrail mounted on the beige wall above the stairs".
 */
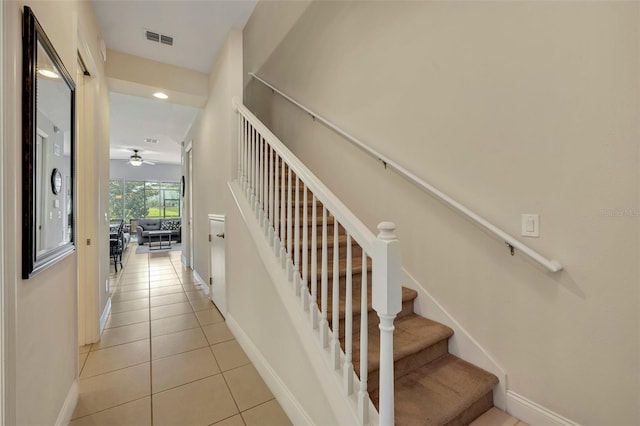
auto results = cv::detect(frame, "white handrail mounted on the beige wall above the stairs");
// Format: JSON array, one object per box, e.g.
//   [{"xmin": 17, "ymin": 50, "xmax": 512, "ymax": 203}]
[{"xmin": 249, "ymin": 72, "xmax": 562, "ymax": 272}]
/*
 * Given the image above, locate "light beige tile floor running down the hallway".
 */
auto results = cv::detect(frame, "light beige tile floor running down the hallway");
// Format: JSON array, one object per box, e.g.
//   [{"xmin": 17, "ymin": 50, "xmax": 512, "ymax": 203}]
[{"xmin": 71, "ymin": 244, "xmax": 291, "ymax": 426}]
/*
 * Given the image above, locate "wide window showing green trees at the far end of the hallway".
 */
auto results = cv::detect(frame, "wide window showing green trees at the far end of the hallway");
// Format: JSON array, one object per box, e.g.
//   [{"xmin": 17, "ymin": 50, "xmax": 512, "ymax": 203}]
[{"xmin": 109, "ymin": 179, "xmax": 180, "ymax": 222}]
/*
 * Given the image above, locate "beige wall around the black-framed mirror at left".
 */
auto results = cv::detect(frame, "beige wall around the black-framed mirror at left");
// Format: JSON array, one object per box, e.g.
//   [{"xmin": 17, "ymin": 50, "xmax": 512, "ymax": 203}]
[{"xmin": 2, "ymin": 1, "xmax": 108, "ymax": 425}]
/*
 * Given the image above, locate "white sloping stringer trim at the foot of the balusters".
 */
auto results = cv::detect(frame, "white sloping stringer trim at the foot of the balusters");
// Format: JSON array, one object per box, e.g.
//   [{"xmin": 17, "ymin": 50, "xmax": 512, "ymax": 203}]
[{"xmin": 228, "ymin": 181, "xmax": 378, "ymax": 426}]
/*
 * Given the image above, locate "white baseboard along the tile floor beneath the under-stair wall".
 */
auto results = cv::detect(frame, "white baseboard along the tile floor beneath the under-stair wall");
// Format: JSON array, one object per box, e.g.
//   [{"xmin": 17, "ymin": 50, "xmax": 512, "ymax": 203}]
[{"xmin": 226, "ymin": 315, "xmax": 314, "ymax": 425}]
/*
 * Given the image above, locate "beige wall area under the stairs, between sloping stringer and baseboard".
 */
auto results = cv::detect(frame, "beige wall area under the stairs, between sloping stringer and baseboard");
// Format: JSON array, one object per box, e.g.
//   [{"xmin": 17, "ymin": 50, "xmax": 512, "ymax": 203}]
[{"xmin": 225, "ymin": 195, "xmax": 340, "ymax": 425}]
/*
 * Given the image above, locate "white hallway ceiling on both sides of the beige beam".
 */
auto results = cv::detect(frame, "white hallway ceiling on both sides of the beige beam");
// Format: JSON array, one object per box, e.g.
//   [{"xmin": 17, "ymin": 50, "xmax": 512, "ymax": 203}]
[{"xmin": 93, "ymin": 0, "xmax": 257, "ymax": 167}]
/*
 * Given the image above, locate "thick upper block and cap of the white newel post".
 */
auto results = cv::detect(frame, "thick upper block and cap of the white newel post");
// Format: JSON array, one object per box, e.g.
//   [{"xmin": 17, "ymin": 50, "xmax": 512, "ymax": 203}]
[{"xmin": 372, "ymin": 222, "xmax": 402, "ymax": 315}]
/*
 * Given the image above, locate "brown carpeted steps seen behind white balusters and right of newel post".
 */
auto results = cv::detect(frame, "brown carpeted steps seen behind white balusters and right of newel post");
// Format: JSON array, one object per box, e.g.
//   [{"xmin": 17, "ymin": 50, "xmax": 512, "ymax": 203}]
[{"xmin": 298, "ymin": 192, "xmax": 498, "ymax": 426}]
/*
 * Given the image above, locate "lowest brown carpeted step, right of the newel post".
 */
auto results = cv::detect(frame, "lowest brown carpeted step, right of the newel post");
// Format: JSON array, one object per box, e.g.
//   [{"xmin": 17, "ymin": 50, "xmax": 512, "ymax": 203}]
[{"xmin": 395, "ymin": 354, "xmax": 498, "ymax": 425}]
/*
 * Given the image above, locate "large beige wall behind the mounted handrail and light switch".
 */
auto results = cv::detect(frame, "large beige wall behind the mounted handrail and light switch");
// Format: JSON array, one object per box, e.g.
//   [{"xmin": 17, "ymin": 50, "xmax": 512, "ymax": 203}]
[{"xmin": 243, "ymin": 1, "xmax": 640, "ymax": 425}]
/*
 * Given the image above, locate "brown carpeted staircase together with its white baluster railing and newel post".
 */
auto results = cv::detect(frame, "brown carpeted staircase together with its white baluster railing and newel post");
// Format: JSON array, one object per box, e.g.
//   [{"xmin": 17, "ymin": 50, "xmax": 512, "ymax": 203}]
[{"xmin": 234, "ymin": 99, "xmax": 498, "ymax": 425}]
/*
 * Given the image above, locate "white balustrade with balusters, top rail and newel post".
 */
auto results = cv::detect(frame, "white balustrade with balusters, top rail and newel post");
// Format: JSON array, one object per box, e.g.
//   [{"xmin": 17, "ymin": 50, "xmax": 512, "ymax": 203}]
[{"xmin": 233, "ymin": 99, "xmax": 402, "ymax": 425}]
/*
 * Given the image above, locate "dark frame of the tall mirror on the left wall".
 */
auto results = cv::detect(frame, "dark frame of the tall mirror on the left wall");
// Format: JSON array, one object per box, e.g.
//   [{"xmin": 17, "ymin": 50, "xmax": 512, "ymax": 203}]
[{"xmin": 22, "ymin": 6, "xmax": 76, "ymax": 279}]
